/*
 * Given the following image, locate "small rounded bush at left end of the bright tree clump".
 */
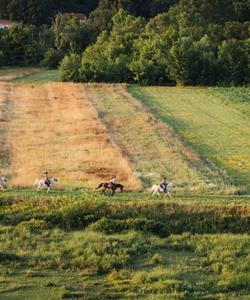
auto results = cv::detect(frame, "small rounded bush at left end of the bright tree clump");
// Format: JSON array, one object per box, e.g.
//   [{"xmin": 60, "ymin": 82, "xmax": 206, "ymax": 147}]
[{"xmin": 60, "ymin": 54, "xmax": 81, "ymax": 82}]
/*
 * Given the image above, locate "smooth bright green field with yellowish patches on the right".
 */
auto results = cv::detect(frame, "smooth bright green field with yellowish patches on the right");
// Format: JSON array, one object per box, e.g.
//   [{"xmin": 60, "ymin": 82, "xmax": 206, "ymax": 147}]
[{"xmin": 129, "ymin": 86, "xmax": 250, "ymax": 191}]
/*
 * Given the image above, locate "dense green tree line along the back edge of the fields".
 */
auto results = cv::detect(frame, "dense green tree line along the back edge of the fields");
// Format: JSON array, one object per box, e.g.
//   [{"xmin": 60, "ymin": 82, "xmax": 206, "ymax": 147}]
[{"xmin": 0, "ymin": 0, "xmax": 250, "ymax": 85}]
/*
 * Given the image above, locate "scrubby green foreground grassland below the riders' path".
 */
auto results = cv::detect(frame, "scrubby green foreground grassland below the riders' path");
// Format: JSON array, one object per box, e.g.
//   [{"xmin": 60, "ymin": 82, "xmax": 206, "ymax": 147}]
[{"xmin": 0, "ymin": 190, "xmax": 250, "ymax": 299}]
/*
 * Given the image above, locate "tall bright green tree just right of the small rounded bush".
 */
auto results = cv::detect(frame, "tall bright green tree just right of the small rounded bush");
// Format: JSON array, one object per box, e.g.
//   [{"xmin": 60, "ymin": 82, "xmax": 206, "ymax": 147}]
[{"xmin": 81, "ymin": 9, "xmax": 145, "ymax": 82}]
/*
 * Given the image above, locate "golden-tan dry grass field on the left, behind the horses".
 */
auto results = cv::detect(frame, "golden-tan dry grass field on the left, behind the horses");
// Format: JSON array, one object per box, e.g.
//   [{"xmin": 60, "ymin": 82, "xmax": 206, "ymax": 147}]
[{"xmin": 0, "ymin": 83, "xmax": 141, "ymax": 190}]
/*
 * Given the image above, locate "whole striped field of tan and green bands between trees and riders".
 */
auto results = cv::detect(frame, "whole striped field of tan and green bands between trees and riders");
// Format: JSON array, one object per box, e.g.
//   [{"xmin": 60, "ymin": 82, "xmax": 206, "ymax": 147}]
[{"xmin": 0, "ymin": 79, "xmax": 250, "ymax": 194}]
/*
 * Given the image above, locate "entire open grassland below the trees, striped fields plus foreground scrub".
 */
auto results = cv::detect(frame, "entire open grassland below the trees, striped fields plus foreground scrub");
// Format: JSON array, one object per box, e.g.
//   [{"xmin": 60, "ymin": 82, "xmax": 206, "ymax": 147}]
[{"xmin": 0, "ymin": 69, "xmax": 250, "ymax": 300}]
